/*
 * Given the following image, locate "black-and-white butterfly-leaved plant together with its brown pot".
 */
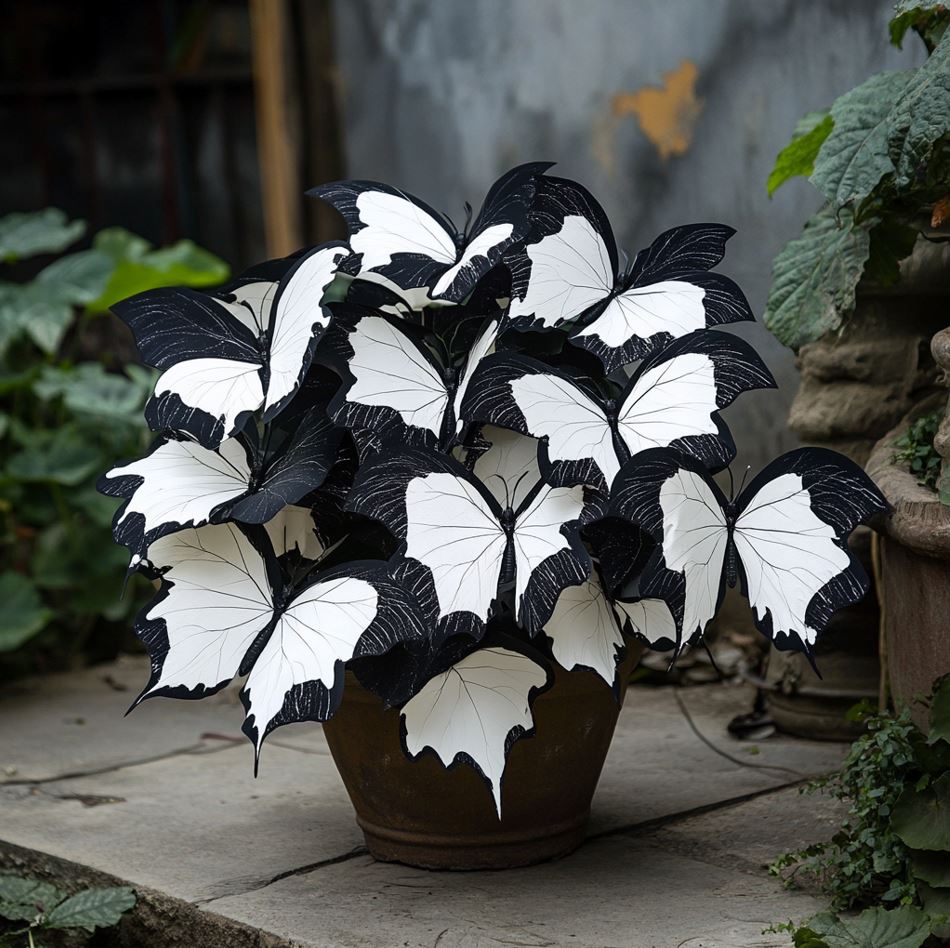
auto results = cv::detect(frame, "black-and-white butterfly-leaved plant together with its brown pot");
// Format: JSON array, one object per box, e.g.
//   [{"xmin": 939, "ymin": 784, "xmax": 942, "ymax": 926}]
[{"xmin": 100, "ymin": 164, "xmax": 884, "ymax": 868}]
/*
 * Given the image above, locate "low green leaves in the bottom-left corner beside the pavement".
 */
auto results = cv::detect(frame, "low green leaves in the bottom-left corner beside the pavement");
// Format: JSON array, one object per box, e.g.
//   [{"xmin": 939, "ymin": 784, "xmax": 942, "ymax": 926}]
[{"xmin": 0, "ymin": 876, "xmax": 136, "ymax": 945}]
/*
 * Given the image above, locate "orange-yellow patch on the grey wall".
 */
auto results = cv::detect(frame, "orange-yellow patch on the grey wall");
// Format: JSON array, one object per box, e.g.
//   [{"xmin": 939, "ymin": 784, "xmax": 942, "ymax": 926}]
[{"xmin": 611, "ymin": 59, "xmax": 703, "ymax": 159}]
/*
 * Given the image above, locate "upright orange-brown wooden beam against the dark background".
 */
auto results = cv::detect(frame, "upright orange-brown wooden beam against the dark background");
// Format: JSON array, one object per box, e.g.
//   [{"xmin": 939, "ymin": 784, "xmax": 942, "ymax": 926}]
[{"xmin": 250, "ymin": 0, "xmax": 303, "ymax": 257}]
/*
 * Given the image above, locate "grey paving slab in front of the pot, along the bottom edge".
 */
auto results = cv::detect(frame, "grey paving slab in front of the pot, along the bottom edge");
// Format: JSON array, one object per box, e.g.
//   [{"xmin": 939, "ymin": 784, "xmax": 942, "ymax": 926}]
[{"xmin": 209, "ymin": 817, "xmax": 820, "ymax": 948}]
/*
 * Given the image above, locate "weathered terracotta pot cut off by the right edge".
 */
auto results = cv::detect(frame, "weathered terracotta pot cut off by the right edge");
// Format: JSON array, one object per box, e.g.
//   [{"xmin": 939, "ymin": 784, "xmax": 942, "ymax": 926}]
[{"xmin": 867, "ymin": 401, "xmax": 950, "ymax": 729}]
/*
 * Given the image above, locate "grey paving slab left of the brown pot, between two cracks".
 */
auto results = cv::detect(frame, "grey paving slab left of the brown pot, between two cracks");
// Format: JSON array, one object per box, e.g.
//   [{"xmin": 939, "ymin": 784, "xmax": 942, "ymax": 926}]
[{"xmin": 0, "ymin": 744, "xmax": 363, "ymax": 902}]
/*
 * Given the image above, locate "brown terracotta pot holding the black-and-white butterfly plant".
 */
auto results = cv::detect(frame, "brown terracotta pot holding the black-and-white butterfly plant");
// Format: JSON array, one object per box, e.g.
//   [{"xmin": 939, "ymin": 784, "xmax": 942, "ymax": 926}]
[{"xmin": 324, "ymin": 644, "xmax": 642, "ymax": 869}]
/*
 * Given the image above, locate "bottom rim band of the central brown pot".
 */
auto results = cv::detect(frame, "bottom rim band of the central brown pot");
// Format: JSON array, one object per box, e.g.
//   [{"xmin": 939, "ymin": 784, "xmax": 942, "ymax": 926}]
[{"xmin": 356, "ymin": 810, "xmax": 590, "ymax": 871}]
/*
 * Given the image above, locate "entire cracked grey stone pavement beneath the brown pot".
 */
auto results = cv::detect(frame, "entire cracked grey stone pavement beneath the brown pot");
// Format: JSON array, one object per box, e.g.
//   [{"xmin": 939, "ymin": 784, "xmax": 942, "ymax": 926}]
[{"xmin": 0, "ymin": 658, "xmax": 843, "ymax": 948}]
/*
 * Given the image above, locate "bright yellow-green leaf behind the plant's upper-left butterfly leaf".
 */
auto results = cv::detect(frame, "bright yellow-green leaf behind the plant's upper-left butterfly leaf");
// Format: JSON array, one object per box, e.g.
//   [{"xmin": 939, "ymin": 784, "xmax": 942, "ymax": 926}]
[{"xmin": 87, "ymin": 227, "xmax": 230, "ymax": 313}]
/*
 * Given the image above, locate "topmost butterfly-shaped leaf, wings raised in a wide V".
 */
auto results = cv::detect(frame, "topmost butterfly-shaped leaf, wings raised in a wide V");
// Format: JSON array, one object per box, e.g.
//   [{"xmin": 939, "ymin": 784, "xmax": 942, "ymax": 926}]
[{"xmin": 307, "ymin": 162, "xmax": 550, "ymax": 302}]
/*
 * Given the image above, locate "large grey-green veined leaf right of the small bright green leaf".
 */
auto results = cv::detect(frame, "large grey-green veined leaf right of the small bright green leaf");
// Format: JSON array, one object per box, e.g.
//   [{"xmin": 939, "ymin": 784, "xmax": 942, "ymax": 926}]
[{"xmin": 810, "ymin": 71, "xmax": 914, "ymax": 207}]
